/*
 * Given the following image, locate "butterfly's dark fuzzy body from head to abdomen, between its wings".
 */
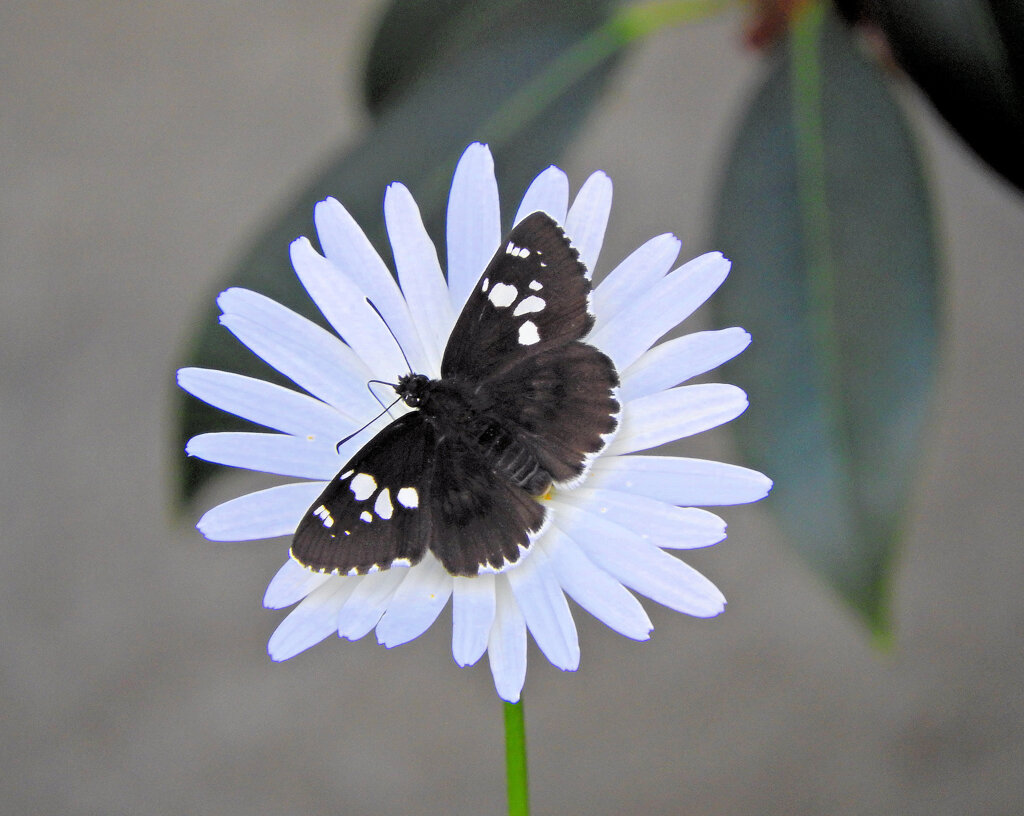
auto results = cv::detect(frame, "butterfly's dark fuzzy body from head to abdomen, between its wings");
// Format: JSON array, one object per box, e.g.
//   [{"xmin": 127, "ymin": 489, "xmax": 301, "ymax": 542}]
[{"xmin": 395, "ymin": 374, "xmax": 551, "ymax": 496}]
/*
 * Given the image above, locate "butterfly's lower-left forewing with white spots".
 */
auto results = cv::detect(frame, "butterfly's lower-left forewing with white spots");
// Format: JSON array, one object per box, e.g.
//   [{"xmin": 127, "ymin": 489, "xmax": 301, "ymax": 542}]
[{"xmin": 291, "ymin": 412, "xmax": 436, "ymax": 575}]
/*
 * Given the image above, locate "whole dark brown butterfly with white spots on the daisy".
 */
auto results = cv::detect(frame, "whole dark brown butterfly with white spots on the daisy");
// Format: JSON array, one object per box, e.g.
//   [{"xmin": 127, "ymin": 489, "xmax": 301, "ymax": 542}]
[{"xmin": 291, "ymin": 212, "xmax": 620, "ymax": 575}]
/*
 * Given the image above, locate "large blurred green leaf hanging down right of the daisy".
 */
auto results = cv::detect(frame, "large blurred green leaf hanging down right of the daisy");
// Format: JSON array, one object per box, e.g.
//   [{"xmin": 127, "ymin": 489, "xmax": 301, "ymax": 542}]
[{"xmin": 714, "ymin": 10, "xmax": 938, "ymax": 639}]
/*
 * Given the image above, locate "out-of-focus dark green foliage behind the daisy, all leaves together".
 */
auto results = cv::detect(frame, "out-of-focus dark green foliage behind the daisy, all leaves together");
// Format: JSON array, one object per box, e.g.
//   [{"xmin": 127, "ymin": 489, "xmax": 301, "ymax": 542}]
[{"xmin": 175, "ymin": 0, "xmax": 1024, "ymax": 639}]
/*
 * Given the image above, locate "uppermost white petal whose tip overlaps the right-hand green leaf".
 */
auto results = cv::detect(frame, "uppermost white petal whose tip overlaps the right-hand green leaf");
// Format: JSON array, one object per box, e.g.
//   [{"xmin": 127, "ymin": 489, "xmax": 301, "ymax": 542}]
[{"xmin": 588, "ymin": 252, "xmax": 729, "ymax": 371}]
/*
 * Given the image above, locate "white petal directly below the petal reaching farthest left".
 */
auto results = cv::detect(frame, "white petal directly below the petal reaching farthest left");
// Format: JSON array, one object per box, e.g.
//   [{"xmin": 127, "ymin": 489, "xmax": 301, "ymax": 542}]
[{"xmin": 185, "ymin": 431, "xmax": 345, "ymax": 479}]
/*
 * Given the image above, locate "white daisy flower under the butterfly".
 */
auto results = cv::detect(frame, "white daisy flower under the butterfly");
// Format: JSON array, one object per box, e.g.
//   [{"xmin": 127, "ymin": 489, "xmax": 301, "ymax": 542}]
[{"xmin": 178, "ymin": 144, "xmax": 771, "ymax": 702}]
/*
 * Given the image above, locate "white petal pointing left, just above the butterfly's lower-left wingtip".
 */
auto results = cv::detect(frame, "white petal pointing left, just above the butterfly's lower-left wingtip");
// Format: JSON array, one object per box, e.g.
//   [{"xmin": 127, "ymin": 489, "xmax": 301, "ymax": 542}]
[{"xmin": 196, "ymin": 481, "xmax": 327, "ymax": 542}]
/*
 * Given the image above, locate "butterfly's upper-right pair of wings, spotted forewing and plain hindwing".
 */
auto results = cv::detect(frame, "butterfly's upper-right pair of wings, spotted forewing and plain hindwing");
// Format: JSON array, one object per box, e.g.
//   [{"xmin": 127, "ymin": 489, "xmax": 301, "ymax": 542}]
[{"xmin": 441, "ymin": 213, "xmax": 620, "ymax": 483}]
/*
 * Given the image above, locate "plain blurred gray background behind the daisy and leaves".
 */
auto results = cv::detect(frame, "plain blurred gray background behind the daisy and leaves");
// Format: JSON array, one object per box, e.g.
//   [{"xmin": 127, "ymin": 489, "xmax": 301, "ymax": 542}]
[{"xmin": 0, "ymin": 0, "xmax": 1024, "ymax": 816}]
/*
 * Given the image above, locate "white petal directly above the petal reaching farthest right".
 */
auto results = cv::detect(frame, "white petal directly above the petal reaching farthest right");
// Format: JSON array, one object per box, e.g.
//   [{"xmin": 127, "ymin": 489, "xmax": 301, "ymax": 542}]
[{"xmin": 606, "ymin": 383, "xmax": 746, "ymax": 456}]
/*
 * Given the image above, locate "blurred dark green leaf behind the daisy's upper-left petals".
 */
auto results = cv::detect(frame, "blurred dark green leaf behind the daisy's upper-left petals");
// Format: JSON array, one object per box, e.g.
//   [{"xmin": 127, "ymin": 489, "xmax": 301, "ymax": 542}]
[{"xmin": 174, "ymin": 0, "xmax": 616, "ymax": 501}]
